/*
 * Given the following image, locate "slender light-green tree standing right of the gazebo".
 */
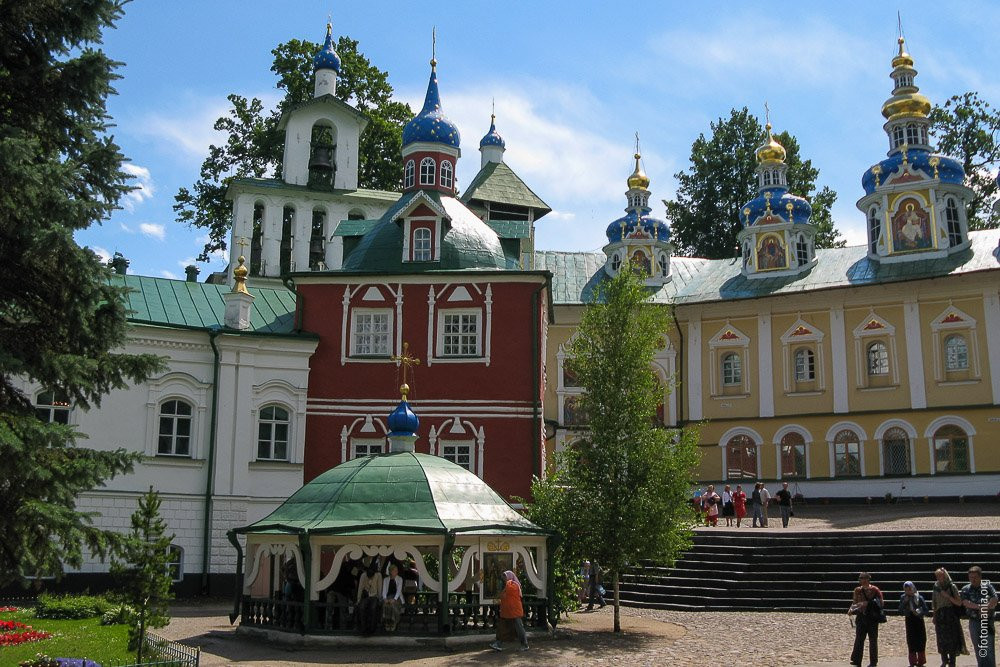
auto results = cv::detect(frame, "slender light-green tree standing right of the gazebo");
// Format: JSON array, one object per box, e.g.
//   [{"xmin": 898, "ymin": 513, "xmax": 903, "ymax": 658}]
[{"xmin": 529, "ymin": 268, "xmax": 698, "ymax": 632}]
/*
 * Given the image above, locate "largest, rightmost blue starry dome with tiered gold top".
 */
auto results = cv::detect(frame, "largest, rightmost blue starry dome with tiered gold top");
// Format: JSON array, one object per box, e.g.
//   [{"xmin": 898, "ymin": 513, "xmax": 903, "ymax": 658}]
[{"xmin": 861, "ymin": 37, "xmax": 965, "ymax": 195}]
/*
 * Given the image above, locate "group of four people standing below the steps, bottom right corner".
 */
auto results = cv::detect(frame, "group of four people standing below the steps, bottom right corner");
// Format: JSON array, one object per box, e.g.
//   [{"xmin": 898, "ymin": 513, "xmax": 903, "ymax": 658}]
[{"xmin": 847, "ymin": 565, "xmax": 998, "ymax": 667}]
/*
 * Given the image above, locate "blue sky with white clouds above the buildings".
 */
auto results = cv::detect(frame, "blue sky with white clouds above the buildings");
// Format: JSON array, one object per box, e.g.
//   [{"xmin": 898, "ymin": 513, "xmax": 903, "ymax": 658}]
[{"xmin": 78, "ymin": 0, "xmax": 1000, "ymax": 279}]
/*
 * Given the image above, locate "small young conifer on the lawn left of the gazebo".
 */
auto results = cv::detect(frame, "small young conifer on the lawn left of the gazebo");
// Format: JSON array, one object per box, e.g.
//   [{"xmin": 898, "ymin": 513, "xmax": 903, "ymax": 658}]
[{"xmin": 110, "ymin": 487, "xmax": 174, "ymax": 663}]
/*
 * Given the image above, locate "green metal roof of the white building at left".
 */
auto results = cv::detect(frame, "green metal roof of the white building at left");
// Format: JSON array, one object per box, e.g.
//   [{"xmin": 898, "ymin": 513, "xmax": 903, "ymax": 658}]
[{"xmin": 111, "ymin": 275, "xmax": 295, "ymax": 334}]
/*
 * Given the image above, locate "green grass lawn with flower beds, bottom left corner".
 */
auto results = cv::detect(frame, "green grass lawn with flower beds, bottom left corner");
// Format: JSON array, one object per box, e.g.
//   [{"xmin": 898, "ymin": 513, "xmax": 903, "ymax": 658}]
[{"xmin": 0, "ymin": 609, "xmax": 135, "ymax": 665}]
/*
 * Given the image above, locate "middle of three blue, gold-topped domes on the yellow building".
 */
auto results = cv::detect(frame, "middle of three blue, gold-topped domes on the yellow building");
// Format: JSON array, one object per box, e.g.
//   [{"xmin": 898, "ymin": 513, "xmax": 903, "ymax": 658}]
[{"xmin": 740, "ymin": 122, "xmax": 812, "ymax": 227}]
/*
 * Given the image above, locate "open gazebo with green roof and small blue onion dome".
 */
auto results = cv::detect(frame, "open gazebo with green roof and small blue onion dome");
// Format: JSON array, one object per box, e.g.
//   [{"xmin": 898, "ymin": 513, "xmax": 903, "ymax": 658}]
[{"xmin": 229, "ymin": 384, "xmax": 553, "ymax": 641}]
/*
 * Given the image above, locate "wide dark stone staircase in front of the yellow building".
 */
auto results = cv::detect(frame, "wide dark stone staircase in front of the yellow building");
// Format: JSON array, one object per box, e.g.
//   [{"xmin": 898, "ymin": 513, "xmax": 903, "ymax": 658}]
[{"xmin": 621, "ymin": 529, "xmax": 1000, "ymax": 613}]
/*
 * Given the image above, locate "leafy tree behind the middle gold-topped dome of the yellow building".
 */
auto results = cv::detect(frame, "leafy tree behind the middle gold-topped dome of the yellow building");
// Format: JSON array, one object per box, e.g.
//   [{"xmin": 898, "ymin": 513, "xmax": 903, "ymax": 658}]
[{"xmin": 663, "ymin": 107, "xmax": 845, "ymax": 259}]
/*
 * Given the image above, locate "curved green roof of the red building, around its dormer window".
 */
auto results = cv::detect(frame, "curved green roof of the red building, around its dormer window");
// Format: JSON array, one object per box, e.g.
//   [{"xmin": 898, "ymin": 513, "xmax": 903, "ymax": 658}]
[{"xmin": 343, "ymin": 190, "xmax": 518, "ymax": 273}]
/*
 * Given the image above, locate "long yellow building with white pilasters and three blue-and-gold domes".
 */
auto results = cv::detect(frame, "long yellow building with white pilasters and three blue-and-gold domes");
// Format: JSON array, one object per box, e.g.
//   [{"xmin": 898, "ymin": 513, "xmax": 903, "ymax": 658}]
[{"xmin": 536, "ymin": 40, "xmax": 1000, "ymax": 497}]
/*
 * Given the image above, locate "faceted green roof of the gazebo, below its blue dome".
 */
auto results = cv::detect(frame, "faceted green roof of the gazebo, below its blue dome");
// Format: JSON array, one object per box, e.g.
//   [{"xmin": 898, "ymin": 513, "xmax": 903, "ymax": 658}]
[{"xmin": 235, "ymin": 452, "xmax": 545, "ymax": 535}]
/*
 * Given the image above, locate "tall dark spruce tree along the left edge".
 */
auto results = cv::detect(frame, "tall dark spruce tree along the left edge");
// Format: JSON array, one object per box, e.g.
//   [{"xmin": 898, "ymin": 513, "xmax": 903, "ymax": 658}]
[{"xmin": 0, "ymin": 0, "xmax": 161, "ymax": 586}]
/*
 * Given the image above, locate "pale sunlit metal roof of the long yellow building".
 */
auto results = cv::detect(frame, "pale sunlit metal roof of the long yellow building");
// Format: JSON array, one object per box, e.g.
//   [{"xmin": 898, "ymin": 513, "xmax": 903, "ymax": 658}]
[{"xmin": 535, "ymin": 229, "xmax": 1000, "ymax": 304}]
